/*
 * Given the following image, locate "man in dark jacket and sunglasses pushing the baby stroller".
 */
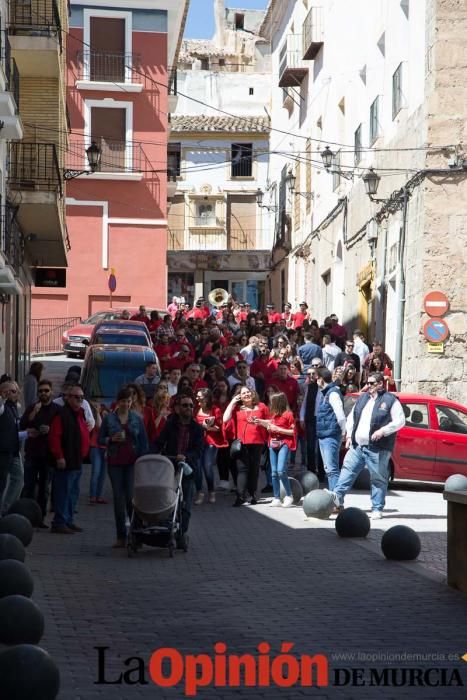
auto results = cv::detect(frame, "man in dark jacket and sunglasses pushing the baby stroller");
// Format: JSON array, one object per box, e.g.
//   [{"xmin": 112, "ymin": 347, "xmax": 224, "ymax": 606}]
[{"xmin": 154, "ymin": 396, "xmax": 204, "ymax": 548}]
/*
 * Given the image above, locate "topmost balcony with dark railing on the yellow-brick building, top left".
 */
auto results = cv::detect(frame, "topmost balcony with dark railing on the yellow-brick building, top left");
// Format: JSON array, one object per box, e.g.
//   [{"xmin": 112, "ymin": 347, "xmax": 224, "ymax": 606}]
[{"xmin": 8, "ymin": 0, "xmax": 63, "ymax": 78}]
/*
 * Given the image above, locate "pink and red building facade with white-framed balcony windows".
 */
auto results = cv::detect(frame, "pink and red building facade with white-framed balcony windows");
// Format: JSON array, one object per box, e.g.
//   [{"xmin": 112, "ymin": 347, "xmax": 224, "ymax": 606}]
[{"xmin": 32, "ymin": 0, "xmax": 188, "ymax": 319}]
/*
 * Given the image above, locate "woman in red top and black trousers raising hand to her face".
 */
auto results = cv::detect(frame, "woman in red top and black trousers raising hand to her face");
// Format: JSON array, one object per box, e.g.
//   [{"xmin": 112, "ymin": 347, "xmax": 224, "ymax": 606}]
[{"xmin": 223, "ymin": 386, "xmax": 269, "ymax": 507}]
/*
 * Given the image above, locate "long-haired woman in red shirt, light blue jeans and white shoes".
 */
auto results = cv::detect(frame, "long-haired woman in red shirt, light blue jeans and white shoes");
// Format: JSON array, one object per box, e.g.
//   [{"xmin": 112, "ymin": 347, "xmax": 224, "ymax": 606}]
[{"xmin": 254, "ymin": 391, "xmax": 297, "ymax": 508}]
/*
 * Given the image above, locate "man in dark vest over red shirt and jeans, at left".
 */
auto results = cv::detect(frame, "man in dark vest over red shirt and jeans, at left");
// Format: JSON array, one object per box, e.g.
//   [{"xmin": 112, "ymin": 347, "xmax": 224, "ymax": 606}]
[{"xmin": 48, "ymin": 384, "xmax": 90, "ymax": 535}]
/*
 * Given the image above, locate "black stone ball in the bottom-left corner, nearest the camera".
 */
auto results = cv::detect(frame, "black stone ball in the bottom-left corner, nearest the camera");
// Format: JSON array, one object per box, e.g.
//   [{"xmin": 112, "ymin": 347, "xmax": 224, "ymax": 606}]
[{"xmin": 0, "ymin": 644, "xmax": 60, "ymax": 700}]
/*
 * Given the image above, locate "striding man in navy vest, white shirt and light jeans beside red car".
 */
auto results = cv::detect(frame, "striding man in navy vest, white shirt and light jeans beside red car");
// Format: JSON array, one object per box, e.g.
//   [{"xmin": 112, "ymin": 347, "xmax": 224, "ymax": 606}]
[{"xmin": 330, "ymin": 372, "xmax": 405, "ymax": 520}]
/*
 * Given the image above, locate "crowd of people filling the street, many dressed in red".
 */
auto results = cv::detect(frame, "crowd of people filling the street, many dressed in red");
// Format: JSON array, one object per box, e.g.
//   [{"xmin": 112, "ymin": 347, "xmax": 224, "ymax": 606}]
[{"xmin": 0, "ymin": 298, "xmax": 400, "ymax": 547}]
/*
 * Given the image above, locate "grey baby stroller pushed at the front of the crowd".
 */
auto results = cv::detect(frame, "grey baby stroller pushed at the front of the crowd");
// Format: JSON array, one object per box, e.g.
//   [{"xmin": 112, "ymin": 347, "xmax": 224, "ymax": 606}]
[{"xmin": 127, "ymin": 454, "xmax": 188, "ymax": 557}]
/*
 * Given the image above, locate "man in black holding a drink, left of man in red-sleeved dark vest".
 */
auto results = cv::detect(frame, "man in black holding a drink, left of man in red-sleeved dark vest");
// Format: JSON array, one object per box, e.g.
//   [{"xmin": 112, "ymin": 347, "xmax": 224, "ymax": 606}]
[{"xmin": 20, "ymin": 379, "xmax": 60, "ymax": 529}]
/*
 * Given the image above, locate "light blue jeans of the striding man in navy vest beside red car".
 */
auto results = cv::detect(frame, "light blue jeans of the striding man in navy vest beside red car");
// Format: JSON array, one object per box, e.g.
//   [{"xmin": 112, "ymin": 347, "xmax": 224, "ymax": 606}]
[{"xmin": 334, "ymin": 445, "xmax": 391, "ymax": 510}]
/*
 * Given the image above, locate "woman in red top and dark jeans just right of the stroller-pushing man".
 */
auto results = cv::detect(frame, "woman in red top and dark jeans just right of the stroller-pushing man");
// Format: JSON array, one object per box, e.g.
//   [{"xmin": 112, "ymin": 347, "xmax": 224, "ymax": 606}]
[{"xmin": 194, "ymin": 389, "xmax": 228, "ymax": 506}]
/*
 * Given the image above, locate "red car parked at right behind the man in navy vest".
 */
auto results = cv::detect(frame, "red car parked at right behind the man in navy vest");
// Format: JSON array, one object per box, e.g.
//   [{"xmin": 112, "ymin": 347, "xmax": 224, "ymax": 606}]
[{"xmin": 344, "ymin": 393, "xmax": 467, "ymax": 482}]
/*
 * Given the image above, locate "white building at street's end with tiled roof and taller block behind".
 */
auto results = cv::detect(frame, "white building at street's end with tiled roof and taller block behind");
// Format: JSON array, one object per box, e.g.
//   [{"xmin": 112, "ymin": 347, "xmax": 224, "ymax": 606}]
[{"xmin": 168, "ymin": 2, "xmax": 273, "ymax": 308}]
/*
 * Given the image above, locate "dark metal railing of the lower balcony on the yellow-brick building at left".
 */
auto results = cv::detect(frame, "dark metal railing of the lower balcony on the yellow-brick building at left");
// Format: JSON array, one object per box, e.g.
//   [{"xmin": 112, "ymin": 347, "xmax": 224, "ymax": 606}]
[{"xmin": 8, "ymin": 141, "xmax": 62, "ymax": 196}]
